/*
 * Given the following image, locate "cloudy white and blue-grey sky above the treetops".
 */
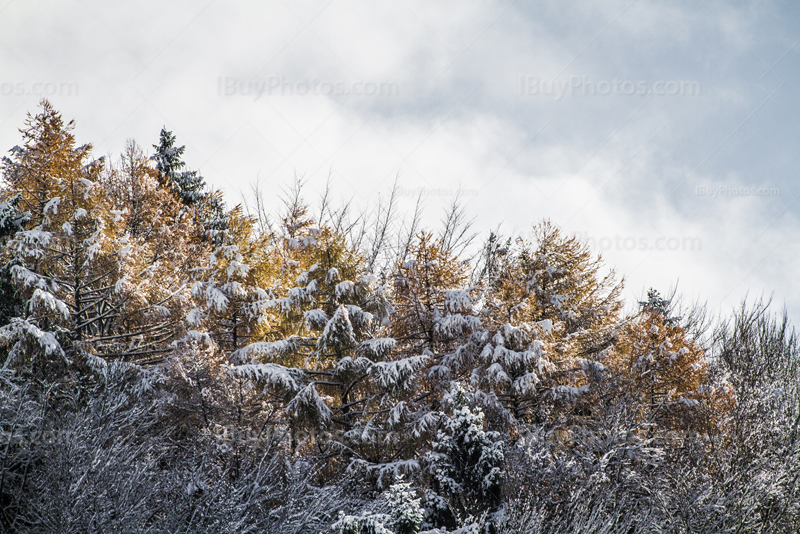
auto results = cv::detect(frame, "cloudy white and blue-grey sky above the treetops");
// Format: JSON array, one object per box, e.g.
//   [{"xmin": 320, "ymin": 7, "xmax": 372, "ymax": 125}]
[{"xmin": 0, "ymin": 0, "xmax": 800, "ymax": 321}]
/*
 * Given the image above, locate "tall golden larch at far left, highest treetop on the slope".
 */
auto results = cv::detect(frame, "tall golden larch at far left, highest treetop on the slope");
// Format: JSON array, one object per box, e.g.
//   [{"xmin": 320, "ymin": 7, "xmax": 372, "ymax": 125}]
[{"xmin": 2, "ymin": 101, "xmax": 121, "ymax": 370}]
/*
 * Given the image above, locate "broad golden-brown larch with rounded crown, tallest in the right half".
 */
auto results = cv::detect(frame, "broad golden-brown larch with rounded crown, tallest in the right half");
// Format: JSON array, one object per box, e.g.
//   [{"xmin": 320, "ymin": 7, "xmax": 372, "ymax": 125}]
[{"xmin": 472, "ymin": 222, "xmax": 622, "ymax": 430}]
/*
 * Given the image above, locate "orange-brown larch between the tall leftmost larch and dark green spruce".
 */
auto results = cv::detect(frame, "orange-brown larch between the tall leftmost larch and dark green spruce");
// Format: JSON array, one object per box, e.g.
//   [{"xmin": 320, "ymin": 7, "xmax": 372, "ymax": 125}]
[{"xmin": 97, "ymin": 141, "xmax": 210, "ymax": 361}]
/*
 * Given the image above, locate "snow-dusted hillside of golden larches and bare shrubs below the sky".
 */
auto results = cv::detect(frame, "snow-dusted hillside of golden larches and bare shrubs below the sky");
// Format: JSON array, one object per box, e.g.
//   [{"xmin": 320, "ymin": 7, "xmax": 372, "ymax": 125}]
[{"xmin": 0, "ymin": 101, "xmax": 800, "ymax": 534}]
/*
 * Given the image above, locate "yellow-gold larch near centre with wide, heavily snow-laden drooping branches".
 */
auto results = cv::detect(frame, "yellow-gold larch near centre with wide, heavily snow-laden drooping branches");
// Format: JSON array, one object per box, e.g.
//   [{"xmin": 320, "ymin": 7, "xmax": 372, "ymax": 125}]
[{"xmin": 234, "ymin": 195, "xmax": 427, "ymax": 480}]
